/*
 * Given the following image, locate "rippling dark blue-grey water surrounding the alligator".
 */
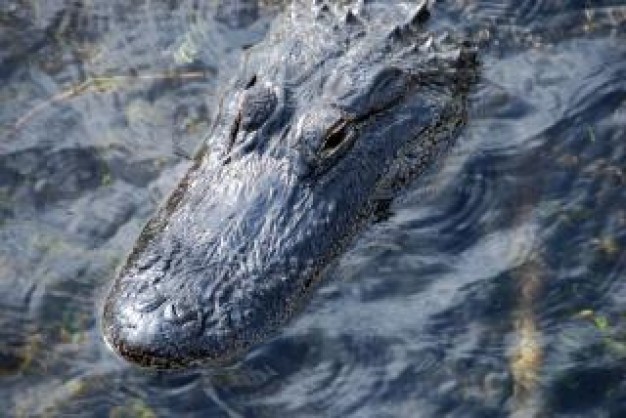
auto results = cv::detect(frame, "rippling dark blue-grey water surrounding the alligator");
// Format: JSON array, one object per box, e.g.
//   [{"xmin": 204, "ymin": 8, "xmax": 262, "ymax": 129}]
[{"xmin": 0, "ymin": 0, "xmax": 626, "ymax": 417}]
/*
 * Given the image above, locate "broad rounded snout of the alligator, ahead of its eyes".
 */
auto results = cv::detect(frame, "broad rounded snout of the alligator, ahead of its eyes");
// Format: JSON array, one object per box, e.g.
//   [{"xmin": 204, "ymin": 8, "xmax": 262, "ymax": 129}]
[{"xmin": 103, "ymin": 154, "xmax": 308, "ymax": 368}]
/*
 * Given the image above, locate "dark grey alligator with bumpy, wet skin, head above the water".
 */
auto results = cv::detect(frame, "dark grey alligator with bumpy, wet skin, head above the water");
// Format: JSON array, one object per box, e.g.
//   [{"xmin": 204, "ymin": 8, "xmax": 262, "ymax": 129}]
[{"xmin": 103, "ymin": 1, "xmax": 475, "ymax": 368}]
